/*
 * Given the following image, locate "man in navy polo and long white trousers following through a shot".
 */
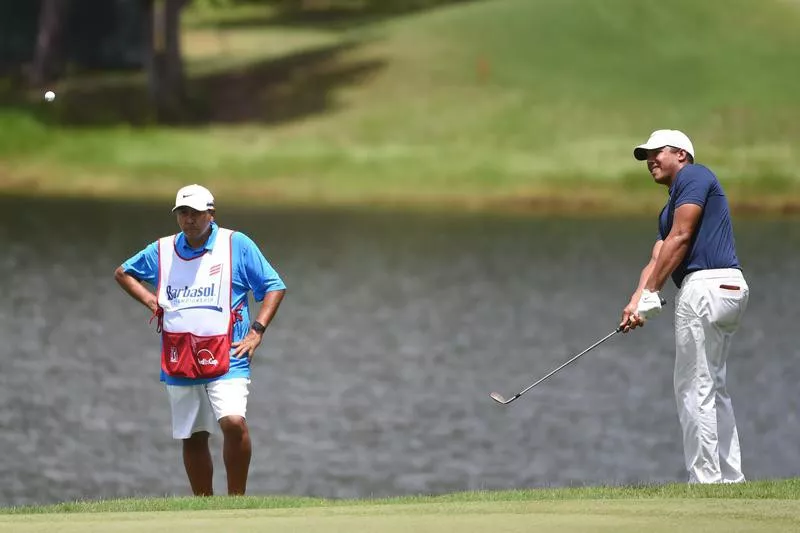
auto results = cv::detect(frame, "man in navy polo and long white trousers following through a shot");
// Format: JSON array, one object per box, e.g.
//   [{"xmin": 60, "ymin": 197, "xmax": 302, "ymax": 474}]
[{"xmin": 620, "ymin": 130, "xmax": 749, "ymax": 483}]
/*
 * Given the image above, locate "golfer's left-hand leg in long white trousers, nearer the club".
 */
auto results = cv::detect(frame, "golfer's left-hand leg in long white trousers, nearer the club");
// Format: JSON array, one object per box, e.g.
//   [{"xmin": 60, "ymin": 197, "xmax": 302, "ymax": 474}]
[{"xmin": 674, "ymin": 283, "xmax": 722, "ymax": 483}]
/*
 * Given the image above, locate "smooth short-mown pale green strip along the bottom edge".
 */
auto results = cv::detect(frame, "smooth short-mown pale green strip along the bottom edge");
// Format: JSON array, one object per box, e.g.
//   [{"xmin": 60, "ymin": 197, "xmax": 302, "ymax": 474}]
[{"xmin": 0, "ymin": 499, "xmax": 800, "ymax": 533}]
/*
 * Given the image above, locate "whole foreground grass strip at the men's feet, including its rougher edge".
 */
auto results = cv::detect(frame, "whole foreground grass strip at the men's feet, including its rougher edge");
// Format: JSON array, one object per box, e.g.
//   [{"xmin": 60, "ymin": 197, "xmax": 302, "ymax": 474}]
[{"xmin": 0, "ymin": 479, "xmax": 800, "ymax": 533}]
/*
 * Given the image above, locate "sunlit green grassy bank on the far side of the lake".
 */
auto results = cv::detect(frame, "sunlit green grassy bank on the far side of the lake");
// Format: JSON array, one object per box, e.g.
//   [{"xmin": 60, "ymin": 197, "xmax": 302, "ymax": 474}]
[{"xmin": 0, "ymin": 0, "xmax": 800, "ymax": 212}]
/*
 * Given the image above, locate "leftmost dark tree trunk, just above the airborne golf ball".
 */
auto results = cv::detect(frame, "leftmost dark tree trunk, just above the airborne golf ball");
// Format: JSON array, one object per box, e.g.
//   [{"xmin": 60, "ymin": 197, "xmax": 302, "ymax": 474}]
[{"xmin": 28, "ymin": 0, "xmax": 69, "ymax": 87}]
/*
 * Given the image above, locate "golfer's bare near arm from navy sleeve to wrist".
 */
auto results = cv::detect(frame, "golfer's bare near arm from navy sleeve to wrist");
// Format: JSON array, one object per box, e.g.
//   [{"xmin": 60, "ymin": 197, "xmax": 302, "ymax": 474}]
[{"xmin": 644, "ymin": 203, "xmax": 703, "ymax": 292}]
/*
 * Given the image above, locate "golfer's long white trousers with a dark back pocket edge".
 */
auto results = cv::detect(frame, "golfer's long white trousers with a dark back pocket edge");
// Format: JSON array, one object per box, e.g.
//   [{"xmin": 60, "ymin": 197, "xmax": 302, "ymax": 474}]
[{"xmin": 674, "ymin": 268, "xmax": 750, "ymax": 483}]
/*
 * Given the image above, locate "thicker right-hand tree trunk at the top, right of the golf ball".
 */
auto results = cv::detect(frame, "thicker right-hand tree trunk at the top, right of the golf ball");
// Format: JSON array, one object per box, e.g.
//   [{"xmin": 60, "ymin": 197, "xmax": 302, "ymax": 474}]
[{"xmin": 145, "ymin": 0, "xmax": 186, "ymax": 122}]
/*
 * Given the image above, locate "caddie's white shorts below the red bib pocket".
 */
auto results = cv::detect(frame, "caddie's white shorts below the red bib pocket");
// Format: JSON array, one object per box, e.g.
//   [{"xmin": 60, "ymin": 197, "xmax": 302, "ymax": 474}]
[{"xmin": 166, "ymin": 378, "xmax": 250, "ymax": 439}]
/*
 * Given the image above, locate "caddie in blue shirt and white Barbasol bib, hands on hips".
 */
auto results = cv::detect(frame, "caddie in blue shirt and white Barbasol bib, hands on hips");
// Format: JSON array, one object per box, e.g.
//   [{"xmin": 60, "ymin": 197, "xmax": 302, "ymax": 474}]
[{"xmin": 114, "ymin": 185, "xmax": 285, "ymax": 496}]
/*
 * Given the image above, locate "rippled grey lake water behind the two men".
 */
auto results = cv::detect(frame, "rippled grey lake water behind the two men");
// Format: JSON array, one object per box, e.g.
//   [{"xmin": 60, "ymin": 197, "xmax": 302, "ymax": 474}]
[{"xmin": 0, "ymin": 194, "xmax": 800, "ymax": 506}]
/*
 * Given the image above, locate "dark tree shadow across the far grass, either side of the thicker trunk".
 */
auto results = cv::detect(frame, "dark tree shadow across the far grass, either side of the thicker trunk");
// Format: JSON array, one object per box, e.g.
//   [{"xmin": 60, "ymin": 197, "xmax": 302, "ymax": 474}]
[{"xmin": 10, "ymin": 43, "xmax": 384, "ymax": 127}]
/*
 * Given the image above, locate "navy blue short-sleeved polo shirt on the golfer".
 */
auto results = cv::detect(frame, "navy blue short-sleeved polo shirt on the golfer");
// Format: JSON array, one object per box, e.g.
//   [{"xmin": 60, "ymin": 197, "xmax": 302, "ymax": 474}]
[{"xmin": 658, "ymin": 164, "xmax": 741, "ymax": 287}]
